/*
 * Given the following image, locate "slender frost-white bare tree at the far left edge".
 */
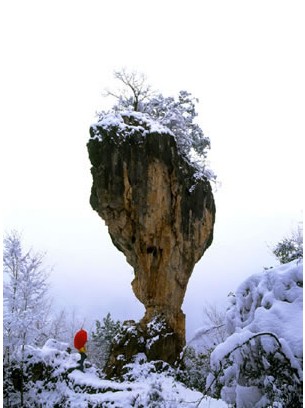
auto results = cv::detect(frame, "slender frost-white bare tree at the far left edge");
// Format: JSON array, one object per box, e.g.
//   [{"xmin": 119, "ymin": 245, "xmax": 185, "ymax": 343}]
[{"xmin": 3, "ymin": 231, "xmax": 50, "ymax": 406}]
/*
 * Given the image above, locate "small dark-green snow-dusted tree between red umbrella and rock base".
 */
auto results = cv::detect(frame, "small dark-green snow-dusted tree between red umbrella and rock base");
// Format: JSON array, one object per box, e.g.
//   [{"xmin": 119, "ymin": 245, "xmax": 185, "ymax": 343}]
[{"xmin": 89, "ymin": 313, "xmax": 121, "ymax": 369}]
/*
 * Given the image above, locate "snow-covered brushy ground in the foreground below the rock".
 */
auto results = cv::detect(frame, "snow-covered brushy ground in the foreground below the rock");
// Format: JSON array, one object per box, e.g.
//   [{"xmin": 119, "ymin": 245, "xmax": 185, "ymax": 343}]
[{"xmin": 13, "ymin": 340, "xmax": 227, "ymax": 408}]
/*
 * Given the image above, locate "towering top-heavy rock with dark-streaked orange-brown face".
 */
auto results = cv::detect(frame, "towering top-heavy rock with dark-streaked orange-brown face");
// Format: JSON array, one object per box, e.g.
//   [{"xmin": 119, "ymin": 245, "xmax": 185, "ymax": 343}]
[{"xmin": 88, "ymin": 112, "xmax": 215, "ymax": 372}]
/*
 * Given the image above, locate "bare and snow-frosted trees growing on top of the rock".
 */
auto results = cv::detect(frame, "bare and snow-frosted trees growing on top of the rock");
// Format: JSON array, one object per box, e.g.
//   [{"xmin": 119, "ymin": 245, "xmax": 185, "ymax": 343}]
[{"xmin": 98, "ymin": 70, "xmax": 215, "ymax": 179}]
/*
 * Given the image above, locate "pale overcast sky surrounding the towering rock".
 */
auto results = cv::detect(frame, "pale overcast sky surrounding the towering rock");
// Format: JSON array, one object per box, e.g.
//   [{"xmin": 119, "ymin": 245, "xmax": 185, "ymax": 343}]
[{"xmin": 0, "ymin": 0, "xmax": 305, "ymax": 337}]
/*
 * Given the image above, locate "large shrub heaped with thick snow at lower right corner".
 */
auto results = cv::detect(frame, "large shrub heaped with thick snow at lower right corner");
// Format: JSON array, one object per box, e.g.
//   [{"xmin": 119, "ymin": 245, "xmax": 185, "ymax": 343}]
[{"xmin": 207, "ymin": 261, "xmax": 303, "ymax": 408}]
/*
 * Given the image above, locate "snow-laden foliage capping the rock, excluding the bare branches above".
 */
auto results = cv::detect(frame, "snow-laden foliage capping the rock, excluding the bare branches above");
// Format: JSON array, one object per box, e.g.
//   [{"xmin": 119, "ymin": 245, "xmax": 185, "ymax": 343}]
[{"xmin": 98, "ymin": 87, "xmax": 216, "ymax": 180}]
